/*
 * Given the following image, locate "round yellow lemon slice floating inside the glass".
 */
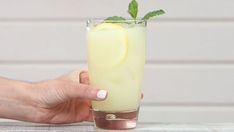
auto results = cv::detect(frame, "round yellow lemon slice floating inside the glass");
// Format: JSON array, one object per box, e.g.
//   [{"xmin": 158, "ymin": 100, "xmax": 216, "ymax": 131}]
[{"xmin": 88, "ymin": 23, "xmax": 128, "ymax": 69}]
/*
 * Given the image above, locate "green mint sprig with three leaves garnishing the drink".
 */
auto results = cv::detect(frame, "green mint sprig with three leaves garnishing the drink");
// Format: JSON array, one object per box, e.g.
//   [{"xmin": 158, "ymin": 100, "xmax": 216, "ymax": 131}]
[{"xmin": 105, "ymin": 0, "xmax": 165, "ymax": 21}]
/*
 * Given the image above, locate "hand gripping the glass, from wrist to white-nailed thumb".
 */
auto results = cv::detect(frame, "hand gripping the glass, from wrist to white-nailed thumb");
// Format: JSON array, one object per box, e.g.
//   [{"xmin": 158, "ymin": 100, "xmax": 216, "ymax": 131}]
[{"xmin": 30, "ymin": 71, "xmax": 106, "ymax": 123}]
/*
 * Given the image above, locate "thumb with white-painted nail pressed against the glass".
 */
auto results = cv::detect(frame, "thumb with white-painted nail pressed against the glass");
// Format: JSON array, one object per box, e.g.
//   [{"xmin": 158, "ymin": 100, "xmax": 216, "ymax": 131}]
[{"xmin": 62, "ymin": 82, "xmax": 107, "ymax": 101}]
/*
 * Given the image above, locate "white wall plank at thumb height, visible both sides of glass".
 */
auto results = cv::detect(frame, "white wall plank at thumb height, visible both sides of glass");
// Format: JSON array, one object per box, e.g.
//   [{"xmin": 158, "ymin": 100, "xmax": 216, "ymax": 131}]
[{"xmin": 0, "ymin": 64, "xmax": 234, "ymax": 106}]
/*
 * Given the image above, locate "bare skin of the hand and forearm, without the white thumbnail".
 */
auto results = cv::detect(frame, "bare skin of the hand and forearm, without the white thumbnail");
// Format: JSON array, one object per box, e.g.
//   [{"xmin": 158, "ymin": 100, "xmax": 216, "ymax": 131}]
[{"xmin": 0, "ymin": 71, "xmax": 105, "ymax": 124}]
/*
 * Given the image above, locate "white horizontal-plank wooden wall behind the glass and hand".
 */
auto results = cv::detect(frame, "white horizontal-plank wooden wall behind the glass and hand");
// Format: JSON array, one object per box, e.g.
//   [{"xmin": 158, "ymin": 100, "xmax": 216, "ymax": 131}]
[{"xmin": 0, "ymin": 0, "xmax": 234, "ymax": 122}]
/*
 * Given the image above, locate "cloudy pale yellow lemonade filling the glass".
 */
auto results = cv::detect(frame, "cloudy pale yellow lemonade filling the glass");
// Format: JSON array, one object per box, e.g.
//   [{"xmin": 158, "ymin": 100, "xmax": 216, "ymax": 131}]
[{"xmin": 87, "ymin": 24, "xmax": 146, "ymax": 112}]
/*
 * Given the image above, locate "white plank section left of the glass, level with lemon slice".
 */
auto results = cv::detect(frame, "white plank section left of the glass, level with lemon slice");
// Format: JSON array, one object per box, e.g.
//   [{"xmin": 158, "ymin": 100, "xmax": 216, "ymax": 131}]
[{"xmin": 0, "ymin": 21, "xmax": 86, "ymax": 61}]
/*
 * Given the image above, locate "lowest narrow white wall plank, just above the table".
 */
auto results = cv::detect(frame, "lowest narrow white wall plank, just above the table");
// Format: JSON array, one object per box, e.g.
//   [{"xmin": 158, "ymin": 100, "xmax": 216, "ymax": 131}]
[{"xmin": 0, "ymin": 105, "xmax": 234, "ymax": 122}]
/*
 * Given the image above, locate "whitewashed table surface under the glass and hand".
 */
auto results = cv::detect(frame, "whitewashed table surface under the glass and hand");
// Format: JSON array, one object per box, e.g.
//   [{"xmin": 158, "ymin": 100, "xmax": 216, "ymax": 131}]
[{"xmin": 0, "ymin": 121, "xmax": 234, "ymax": 132}]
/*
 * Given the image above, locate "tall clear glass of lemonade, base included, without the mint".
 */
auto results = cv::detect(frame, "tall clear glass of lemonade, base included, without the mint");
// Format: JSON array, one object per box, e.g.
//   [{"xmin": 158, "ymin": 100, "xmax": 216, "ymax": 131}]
[{"xmin": 87, "ymin": 19, "xmax": 146, "ymax": 130}]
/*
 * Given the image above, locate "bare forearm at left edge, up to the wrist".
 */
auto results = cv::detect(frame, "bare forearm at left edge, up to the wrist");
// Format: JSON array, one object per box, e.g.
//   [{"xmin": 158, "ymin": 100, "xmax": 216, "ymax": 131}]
[{"xmin": 0, "ymin": 77, "xmax": 35, "ymax": 121}]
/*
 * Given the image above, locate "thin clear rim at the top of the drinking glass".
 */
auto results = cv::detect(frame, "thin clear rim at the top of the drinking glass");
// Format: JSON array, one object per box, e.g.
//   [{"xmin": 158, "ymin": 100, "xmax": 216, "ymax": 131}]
[{"xmin": 86, "ymin": 18, "xmax": 147, "ymax": 24}]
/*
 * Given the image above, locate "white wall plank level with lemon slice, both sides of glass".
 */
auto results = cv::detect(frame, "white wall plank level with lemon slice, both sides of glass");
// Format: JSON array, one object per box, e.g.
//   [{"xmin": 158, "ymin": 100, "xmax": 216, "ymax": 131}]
[{"xmin": 0, "ymin": 21, "xmax": 234, "ymax": 62}]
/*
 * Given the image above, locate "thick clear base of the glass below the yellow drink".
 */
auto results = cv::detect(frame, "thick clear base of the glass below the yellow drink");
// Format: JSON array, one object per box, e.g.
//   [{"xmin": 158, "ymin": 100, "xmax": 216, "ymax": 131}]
[{"xmin": 93, "ymin": 110, "xmax": 139, "ymax": 130}]
